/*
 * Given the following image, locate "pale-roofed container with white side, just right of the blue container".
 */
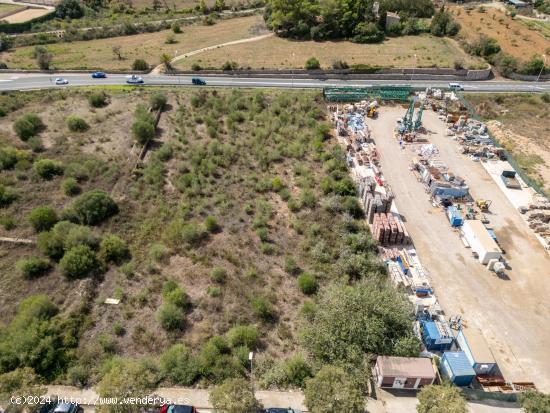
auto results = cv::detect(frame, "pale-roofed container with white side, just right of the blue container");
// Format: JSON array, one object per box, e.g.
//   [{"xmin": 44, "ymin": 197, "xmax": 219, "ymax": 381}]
[{"xmin": 456, "ymin": 328, "xmax": 497, "ymax": 374}]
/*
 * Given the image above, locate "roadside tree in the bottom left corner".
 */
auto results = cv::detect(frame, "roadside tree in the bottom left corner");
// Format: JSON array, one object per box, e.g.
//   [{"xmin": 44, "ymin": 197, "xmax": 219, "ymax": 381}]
[{"xmin": 0, "ymin": 367, "xmax": 46, "ymax": 413}]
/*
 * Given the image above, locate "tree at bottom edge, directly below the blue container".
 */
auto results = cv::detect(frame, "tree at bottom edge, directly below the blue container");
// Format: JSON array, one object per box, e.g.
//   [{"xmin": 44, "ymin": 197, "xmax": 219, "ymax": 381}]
[{"xmin": 416, "ymin": 384, "xmax": 467, "ymax": 413}]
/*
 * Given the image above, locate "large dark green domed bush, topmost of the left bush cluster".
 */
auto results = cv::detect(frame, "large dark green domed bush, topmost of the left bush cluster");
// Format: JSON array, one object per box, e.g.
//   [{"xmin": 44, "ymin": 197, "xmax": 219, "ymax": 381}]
[{"xmin": 68, "ymin": 189, "xmax": 118, "ymax": 225}]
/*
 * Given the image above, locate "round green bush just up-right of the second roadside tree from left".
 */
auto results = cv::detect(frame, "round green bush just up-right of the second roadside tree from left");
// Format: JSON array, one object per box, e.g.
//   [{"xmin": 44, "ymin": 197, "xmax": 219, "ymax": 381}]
[{"xmin": 160, "ymin": 344, "xmax": 199, "ymax": 386}]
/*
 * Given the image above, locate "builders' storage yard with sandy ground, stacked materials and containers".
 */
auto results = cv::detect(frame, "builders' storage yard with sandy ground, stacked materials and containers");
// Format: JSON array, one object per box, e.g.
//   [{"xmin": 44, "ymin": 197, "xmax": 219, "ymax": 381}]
[{"xmin": 325, "ymin": 88, "xmax": 550, "ymax": 396}]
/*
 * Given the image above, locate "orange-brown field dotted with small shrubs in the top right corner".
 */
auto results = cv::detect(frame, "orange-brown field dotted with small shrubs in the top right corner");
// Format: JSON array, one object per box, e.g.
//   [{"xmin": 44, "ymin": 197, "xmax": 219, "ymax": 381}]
[{"xmin": 450, "ymin": 6, "xmax": 550, "ymax": 61}]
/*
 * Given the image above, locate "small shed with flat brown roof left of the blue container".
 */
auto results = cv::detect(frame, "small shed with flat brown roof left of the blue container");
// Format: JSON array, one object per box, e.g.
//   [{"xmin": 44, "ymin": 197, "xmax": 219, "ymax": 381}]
[{"xmin": 374, "ymin": 356, "xmax": 436, "ymax": 390}]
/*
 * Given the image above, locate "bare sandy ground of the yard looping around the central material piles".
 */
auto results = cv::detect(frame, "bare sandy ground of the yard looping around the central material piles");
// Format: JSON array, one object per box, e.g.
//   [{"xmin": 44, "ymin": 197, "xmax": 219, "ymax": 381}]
[{"xmin": 368, "ymin": 106, "xmax": 550, "ymax": 391}]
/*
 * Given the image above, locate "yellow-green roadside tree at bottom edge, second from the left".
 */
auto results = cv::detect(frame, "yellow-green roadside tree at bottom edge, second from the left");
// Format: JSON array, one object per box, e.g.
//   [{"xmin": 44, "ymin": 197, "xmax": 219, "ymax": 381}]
[{"xmin": 97, "ymin": 357, "xmax": 156, "ymax": 413}]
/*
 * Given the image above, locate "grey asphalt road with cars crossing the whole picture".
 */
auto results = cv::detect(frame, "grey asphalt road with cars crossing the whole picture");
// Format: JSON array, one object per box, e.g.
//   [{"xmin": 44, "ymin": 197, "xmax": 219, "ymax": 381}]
[{"xmin": 0, "ymin": 73, "xmax": 550, "ymax": 92}]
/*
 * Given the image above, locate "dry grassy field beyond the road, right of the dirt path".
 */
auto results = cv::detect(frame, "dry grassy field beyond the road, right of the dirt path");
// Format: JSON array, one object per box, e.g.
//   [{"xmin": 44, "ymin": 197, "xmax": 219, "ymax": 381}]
[{"xmin": 177, "ymin": 36, "xmax": 481, "ymax": 69}]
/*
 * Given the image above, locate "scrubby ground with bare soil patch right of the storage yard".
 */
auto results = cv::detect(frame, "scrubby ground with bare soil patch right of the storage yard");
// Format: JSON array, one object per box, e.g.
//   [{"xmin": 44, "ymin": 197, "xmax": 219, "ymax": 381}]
[{"xmin": 467, "ymin": 94, "xmax": 550, "ymax": 194}]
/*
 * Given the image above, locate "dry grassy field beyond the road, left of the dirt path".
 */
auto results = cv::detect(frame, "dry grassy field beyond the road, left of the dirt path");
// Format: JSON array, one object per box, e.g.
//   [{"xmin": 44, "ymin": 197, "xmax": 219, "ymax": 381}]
[{"xmin": 0, "ymin": 16, "xmax": 263, "ymax": 70}]
